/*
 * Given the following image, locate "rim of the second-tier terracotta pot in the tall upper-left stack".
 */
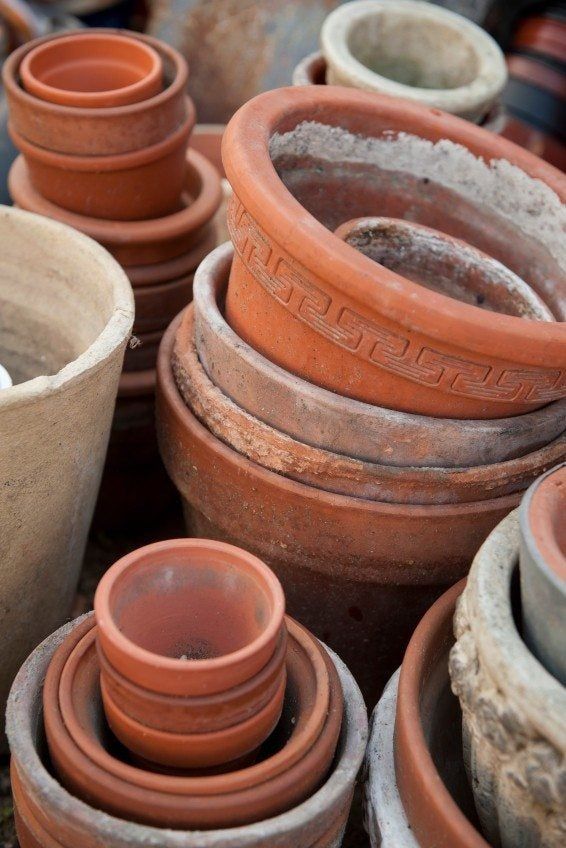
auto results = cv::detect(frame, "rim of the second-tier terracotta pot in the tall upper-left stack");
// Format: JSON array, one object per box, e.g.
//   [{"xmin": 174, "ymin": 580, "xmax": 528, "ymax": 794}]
[{"xmin": 8, "ymin": 97, "xmax": 196, "ymax": 174}]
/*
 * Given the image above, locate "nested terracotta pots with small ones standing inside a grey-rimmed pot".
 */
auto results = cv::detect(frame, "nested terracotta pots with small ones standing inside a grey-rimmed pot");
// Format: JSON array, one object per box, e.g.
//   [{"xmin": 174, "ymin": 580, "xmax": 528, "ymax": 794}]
[{"xmin": 7, "ymin": 539, "xmax": 367, "ymax": 848}]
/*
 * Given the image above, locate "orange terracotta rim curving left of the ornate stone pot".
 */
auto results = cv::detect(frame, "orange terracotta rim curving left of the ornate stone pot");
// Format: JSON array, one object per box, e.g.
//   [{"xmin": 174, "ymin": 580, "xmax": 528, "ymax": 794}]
[{"xmin": 393, "ymin": 578, "xmax": 488, "ymax": 848}]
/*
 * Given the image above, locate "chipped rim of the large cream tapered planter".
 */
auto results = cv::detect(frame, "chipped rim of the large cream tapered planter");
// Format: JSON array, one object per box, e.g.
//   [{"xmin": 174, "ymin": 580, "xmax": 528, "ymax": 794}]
[{"xmin": 0, "ymin": 206, "xmax": 134, "ymax": 409}]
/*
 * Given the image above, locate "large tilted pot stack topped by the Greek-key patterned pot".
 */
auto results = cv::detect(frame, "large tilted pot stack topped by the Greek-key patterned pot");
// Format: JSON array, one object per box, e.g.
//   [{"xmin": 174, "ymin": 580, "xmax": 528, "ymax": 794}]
[{"xmin": 158, "ymin": 86, "xmax": 566, "ymax": 703}]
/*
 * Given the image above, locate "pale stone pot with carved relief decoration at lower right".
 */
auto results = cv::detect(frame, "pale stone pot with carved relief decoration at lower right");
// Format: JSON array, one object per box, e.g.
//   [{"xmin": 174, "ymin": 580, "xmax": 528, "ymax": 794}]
[{"xmin": 450, "ymin": 513, "xmax": 566, "ymax": 848}]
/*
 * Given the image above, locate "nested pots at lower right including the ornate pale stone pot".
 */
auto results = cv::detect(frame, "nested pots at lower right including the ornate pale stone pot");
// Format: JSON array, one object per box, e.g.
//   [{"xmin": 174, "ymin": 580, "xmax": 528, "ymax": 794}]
[{"xmin": 366, "ymin": 465, "xmax": 566, "ymax": 848}]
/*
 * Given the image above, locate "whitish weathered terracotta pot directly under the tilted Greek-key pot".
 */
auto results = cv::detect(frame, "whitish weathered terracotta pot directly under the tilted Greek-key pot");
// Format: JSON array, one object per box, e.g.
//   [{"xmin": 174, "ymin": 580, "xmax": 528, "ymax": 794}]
[{"xmin": 194, "ymin": 245, "xmax": 566, "ymax": 467}]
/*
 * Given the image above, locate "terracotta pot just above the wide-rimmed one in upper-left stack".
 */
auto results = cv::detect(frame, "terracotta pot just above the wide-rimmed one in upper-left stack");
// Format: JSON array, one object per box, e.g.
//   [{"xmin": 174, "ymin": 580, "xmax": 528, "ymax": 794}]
[{"xmin": 9, "ymin": 104, "xmax": 195, "ymax": 221}]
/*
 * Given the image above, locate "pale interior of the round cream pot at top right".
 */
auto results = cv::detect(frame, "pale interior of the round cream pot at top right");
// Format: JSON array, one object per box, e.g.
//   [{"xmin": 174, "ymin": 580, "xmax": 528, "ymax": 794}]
[{"xmin": 347, "ymin": 9, "xmax": 478, "ymax": 89}]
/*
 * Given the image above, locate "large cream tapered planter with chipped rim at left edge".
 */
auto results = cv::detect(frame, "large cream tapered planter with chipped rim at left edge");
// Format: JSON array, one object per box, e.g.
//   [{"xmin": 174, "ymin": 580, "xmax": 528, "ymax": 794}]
[{"xmin": 0, "ymin": 207, "xmax": 134, "ymax": 745}]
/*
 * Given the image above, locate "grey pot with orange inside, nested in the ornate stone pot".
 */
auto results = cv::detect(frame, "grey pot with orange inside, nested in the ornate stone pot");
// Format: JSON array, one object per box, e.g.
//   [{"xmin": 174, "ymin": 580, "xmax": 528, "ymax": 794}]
[{"xmin": 519, "ymin": 464, "xmax": 566, "ymax": 686}]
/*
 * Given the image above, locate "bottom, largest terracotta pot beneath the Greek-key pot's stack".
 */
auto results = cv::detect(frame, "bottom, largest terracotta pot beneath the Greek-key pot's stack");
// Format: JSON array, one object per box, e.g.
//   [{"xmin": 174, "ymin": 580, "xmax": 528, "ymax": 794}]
[{"xmin": 156, "ymin": 312, "xmax": 519, "ymax": 703}]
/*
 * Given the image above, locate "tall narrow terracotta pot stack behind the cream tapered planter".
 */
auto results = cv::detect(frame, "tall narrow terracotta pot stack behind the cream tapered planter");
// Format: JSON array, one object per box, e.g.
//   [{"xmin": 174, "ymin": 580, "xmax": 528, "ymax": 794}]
[{"xmin": 3, "ymin": 30, "xmax": 222, "ymax": 524}]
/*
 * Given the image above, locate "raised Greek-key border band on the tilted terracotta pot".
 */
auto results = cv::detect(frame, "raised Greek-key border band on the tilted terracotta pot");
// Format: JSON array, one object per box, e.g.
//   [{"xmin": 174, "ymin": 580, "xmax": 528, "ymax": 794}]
[{"xmin": 228, "ymin": 195, "xmax": 566, "ymax": 403}]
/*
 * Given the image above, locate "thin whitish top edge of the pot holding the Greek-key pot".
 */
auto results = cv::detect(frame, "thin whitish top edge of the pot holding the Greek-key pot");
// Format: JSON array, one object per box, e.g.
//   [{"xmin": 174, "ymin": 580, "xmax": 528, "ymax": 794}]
[{"xmin": 193, "ymin": 242, "xmax": 566, "ymax": 461}]
